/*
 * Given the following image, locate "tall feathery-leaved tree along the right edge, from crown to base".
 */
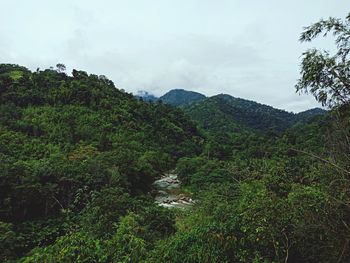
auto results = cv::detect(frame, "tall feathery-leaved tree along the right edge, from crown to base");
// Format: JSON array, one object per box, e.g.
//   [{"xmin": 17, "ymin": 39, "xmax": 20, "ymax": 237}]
[{"xmin": 296, "ymin": 13, "xmax": 350, "ymax": 262}]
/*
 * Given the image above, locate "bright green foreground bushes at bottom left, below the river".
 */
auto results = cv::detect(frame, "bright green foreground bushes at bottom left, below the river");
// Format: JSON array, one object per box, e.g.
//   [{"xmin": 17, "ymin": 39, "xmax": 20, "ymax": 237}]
[{"xmin": 21, "ymin": 210, "xmax": 175, "ymax": 263}]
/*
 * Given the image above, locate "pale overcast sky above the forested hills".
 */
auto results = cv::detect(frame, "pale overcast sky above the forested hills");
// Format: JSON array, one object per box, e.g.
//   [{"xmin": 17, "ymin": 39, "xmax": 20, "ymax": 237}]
[{"xmin": 0, "ymin": 0, "xmax": 350, "ymax": 112}]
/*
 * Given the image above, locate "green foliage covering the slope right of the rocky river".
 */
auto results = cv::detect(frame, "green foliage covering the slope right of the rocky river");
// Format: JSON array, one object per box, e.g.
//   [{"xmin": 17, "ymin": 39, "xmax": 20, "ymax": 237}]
[{"xmin": 168, "ymin": 99, "xmax": 350, "ymax": 262}]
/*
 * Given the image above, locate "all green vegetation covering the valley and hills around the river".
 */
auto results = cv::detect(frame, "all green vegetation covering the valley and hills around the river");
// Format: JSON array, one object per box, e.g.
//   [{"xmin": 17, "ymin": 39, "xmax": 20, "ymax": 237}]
[{"xmin": 0, "ymin": 12, "xmax": 350, "ymax": 263}]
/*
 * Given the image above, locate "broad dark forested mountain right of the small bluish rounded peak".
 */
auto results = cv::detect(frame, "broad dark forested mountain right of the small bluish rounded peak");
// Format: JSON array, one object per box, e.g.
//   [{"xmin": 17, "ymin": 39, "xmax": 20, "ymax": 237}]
[{"xmin": 184, "ymin": 94, "xmax": 325, "ymax": 133}]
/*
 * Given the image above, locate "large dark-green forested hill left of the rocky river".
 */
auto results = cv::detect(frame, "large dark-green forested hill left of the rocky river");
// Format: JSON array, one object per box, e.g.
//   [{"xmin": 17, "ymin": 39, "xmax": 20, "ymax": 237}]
[{"xmin": 0, "ymin": 64, "xmax": 203, "ymax": 262}]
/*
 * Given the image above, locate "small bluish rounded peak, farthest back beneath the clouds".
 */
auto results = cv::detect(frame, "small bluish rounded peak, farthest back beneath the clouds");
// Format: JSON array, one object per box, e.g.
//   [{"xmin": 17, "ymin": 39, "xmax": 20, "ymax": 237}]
[{"xmin": 159, "ymin": 89, "xmax": 206, "ymax": 107}]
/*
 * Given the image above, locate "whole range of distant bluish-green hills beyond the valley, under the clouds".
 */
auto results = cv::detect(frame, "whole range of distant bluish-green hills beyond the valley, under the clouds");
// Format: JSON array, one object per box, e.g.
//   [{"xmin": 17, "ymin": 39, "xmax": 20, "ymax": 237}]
[{"xmin": 137, "ymin": 89, "xmax": 326, "ymax": 133}]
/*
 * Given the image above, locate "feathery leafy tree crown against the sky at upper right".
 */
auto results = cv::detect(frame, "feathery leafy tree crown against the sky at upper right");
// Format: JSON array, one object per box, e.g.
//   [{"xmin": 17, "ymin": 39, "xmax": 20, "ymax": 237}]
[{"xmin": 296, "ymin": 13, "xmax": 350, "ymax": 108}]
